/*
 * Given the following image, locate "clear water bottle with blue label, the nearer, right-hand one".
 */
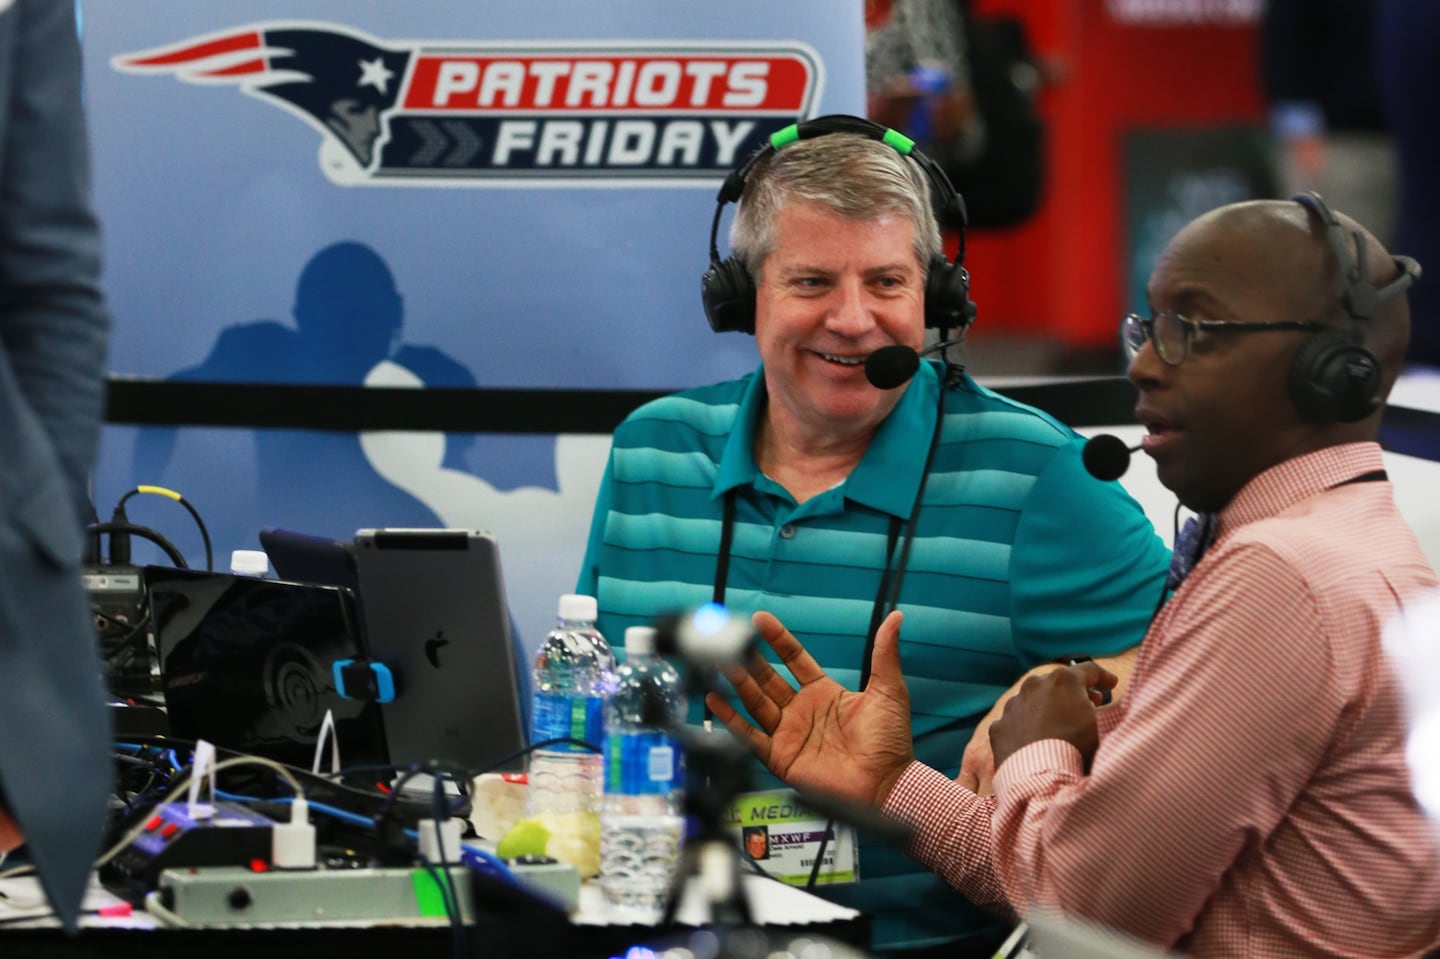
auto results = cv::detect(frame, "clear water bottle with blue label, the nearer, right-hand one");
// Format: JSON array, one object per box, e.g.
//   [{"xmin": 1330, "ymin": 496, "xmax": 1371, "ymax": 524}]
[{"xmin": 600, "ymin": 626, "xmax": 685, "ymax": 919}]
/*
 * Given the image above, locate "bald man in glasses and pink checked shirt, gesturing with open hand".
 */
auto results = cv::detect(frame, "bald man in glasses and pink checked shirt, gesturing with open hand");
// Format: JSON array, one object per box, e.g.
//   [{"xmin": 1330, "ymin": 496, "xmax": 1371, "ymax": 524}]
[{"xmin": 708, "ymin": 194, "xmax": 1440, "ymax": 958}]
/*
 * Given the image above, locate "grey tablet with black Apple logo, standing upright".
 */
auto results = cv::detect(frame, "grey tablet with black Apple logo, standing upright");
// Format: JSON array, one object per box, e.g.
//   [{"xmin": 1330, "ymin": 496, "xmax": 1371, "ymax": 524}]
[{"xmin": 356, "ymin": 528, "xmax": 528, "ymax": 772}]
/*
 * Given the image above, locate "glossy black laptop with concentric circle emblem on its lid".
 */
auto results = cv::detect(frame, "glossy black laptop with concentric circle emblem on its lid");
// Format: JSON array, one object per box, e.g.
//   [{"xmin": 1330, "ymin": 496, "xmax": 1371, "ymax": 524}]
[{"xmin": 143, "ymin": 566, "xmax": 386, "ymax": 769}]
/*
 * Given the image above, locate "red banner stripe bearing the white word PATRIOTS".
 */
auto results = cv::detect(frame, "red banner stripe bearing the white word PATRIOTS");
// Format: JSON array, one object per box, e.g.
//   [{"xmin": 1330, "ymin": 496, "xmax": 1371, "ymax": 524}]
[{"xmin": 405, "ymin": 52, "xmax": 814, "ymax": 114}]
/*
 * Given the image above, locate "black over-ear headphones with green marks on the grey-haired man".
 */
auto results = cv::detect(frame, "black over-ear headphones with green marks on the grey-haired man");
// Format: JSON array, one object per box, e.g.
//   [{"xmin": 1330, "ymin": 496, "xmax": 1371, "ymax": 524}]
[{"xmin": 700, "ymin": 114, "xmax": 975, "ymax": 334}]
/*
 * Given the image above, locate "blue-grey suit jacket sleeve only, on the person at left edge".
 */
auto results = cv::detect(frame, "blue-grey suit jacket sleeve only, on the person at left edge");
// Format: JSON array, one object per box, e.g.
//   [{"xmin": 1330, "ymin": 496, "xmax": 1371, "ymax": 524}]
[{"xmin": 0, "ymin": 0, "xmax": 108, "ymax": 517}]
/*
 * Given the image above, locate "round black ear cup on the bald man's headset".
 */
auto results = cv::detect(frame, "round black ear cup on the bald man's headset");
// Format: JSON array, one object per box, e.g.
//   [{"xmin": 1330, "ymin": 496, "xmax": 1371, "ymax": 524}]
[{"xmin": 1290, "ymin": 333, "xmax": 1380, "ymax": 423}]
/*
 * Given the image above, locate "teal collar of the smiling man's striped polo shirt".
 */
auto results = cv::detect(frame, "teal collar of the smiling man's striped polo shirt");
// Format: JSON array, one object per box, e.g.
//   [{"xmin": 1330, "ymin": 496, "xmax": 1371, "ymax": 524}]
[{"xmin": 711, "ymin": 363, "xmax": 940, "ymax": 520}]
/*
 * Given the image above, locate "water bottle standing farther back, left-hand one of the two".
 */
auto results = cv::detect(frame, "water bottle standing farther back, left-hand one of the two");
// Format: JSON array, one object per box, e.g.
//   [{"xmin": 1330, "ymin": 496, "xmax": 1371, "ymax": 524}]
[{"xmin": 526, "ymin": 595, "xmax": 615, "ymax": 815}]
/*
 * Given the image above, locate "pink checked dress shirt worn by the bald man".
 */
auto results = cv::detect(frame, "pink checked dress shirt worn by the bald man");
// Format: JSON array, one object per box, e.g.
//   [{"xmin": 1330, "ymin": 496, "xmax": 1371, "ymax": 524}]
[{"xmin": 886, "ymin": 444, "xmax": 1440, "ymax": 958}]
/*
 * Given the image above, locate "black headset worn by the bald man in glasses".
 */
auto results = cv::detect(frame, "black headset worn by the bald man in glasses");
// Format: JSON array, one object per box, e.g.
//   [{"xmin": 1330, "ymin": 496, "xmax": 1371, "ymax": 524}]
[{"xmin": 1289, "ymin": 192, "xmax": 1420, "ymax": 423}]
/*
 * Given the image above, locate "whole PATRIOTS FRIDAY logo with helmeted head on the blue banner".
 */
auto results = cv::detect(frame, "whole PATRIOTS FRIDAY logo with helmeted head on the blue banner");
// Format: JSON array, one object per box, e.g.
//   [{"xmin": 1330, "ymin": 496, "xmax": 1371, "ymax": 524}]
[{"xmin": 111, "ymin": 22, "xmax": 822, "ymax": 186}]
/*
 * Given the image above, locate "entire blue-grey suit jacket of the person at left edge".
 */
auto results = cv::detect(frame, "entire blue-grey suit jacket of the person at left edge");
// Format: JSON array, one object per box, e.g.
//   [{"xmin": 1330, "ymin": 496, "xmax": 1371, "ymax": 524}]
[{"xmin": 0, "ymin": 0, "xmax": 111, "ymax": 927}]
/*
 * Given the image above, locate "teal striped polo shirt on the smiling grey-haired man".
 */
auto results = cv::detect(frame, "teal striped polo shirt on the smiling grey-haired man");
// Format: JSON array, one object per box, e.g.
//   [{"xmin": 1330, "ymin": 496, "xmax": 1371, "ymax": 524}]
[{"xmin": 577, "ymin": 363, "xmax": 1169, "ymax": 947}]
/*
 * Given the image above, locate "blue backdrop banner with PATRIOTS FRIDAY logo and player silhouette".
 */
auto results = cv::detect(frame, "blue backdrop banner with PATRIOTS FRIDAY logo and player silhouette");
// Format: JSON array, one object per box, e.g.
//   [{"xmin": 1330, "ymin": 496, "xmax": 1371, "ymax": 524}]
[{"xmin": 81, "ymin": 0, "xmax": 864, "ymax": 645}]
